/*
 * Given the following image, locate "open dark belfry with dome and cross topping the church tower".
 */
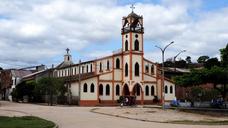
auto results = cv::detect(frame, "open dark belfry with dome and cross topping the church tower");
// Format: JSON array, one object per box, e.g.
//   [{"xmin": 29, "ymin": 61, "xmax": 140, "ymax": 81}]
[{"xmin": 122, "ymin": 5, "xmax": 144, "ymax": 34}]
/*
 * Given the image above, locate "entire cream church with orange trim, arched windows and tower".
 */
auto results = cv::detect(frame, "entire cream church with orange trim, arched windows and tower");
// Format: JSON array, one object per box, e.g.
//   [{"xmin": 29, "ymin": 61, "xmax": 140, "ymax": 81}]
[{"xmin": 54, "ymin": 11, "xmax": 175, "ymax": 106}]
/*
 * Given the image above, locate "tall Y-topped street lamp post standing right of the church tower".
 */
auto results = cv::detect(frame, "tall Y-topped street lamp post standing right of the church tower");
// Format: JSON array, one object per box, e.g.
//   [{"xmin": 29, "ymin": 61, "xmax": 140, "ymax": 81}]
[{"xmin": 155, "ymin": 41, "xmax": 174, "ymax": 109}]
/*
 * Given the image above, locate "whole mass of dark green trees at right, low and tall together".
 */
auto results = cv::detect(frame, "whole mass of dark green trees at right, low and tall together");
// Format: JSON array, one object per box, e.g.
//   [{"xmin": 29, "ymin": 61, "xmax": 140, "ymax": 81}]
[{"xmin": 174, "ymin": 44, "xmax": 228, "ymax": 98}]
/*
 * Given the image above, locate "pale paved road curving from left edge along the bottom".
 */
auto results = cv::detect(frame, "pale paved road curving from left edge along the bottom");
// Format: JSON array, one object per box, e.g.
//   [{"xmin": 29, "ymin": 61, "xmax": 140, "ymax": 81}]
[{"xmin": 0, "ymin": 101, "xmax": 227, "ymax": 128}]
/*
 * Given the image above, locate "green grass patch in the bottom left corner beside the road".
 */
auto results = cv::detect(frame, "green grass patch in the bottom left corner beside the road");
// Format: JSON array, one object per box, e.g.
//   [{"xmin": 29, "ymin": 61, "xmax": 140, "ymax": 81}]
[{"xmin": 0, "ymin": 116, "xmax": 55, "ymax": 128}]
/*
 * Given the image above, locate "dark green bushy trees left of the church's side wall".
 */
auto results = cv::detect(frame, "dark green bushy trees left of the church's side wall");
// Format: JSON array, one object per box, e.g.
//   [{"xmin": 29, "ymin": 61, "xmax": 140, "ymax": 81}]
[{"xmin": 11, "ymin": 77, "xmax": 67, "ymax": 105}]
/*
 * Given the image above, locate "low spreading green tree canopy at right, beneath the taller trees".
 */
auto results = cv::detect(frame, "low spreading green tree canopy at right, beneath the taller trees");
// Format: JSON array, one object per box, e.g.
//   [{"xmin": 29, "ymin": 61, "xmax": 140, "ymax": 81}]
[{"xmin": 174, "ymin": 66, "xmax": 228, "ymax": 98}]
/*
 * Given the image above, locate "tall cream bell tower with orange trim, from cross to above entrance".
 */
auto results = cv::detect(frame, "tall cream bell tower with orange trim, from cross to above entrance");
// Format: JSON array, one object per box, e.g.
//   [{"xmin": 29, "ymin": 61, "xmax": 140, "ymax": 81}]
[{"xmin": 121, "ymin": 5, "xmax": 144, "ymax": 86}]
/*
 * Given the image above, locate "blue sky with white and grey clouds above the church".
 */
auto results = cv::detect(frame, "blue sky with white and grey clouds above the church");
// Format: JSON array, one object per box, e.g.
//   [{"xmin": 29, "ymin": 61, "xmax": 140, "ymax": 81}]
[{"xmin": 0, "ymin": 0, "xmax": 228, "ymax": 68}]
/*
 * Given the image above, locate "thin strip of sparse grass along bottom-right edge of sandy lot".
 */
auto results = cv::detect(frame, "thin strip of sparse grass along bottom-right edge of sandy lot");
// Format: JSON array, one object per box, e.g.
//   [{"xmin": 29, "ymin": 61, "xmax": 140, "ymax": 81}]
[{"xmin": 166, "ymin": 120, "xmax": 228, "ymax": 125}]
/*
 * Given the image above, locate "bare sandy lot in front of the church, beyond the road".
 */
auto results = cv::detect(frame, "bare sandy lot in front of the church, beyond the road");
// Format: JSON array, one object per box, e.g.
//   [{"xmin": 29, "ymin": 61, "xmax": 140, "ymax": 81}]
[{"xmin": 92, "ymin": 106, "xmax": 228, "ymax": 123}]
